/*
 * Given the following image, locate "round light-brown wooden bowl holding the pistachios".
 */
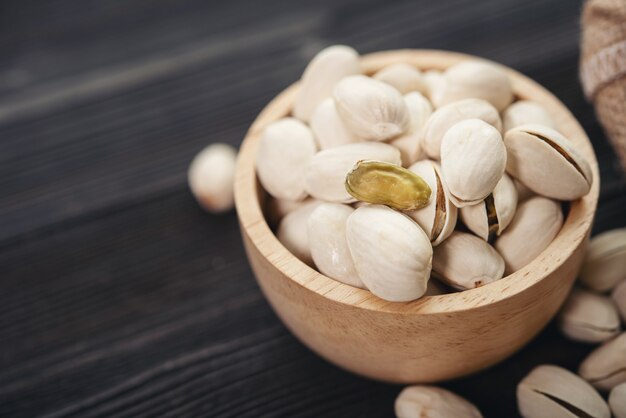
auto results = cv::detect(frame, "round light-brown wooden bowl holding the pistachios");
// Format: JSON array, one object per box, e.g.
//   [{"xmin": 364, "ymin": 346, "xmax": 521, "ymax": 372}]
[{"xmin": 235, "ymin": 50, "xmax": 600, "ymax": 383}]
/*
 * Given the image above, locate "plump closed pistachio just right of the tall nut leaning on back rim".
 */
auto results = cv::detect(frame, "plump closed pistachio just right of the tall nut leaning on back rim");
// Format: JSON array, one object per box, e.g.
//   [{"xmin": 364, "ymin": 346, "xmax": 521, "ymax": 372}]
[{"xmin": 333, "ymin": 75, "xmax": 411, "ymax": 141}]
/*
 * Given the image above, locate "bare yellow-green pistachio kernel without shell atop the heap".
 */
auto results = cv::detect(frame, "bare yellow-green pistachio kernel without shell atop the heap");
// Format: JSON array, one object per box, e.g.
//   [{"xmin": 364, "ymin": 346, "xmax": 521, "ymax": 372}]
[{"xmin": 346, "ymin": 161, "xmax": 431, "ymax": 210}]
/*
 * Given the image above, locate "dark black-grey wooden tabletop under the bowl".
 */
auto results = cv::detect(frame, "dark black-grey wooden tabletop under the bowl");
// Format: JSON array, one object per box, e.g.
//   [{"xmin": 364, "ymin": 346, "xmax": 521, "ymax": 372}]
[{"xmin": 0, "ymin": 0, "xmax": 626, "ymax": 417}]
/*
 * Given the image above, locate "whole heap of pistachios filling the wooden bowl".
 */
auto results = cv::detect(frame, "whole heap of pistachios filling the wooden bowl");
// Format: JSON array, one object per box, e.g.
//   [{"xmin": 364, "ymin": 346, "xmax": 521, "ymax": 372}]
[{"xmin": 256, "ymin": 46, "xmax": 592, "ymax": 302}]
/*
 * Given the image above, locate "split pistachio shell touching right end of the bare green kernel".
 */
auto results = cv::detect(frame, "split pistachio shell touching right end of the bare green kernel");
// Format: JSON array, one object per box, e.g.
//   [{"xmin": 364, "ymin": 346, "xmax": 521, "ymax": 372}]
[{"xmin": 406, "ymin": 160, "xmax": 457, "ymax": 245}]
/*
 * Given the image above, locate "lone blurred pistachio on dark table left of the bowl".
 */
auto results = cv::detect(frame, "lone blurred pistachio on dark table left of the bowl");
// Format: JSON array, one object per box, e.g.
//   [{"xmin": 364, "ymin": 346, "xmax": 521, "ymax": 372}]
[{"xmin": 187, "ymin": 144, "xmax": 237, "ymax": 213}]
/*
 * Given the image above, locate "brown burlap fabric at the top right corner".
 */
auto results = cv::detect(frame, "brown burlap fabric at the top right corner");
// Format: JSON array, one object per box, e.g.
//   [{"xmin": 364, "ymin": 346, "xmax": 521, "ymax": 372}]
[{"xmin": 580, "ymin": 0, "xmax": 626, "ymax": 170}]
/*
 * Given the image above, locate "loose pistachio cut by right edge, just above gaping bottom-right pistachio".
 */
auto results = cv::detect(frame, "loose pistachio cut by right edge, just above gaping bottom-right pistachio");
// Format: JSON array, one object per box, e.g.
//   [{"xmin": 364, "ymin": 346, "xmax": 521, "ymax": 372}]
[{"xmin": 578, "ymin": 333, "xmax": 626, "ymax": 391}]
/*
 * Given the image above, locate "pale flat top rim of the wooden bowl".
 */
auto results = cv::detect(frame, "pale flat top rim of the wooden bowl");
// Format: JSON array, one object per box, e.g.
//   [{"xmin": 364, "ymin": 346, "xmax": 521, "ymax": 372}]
[{"xmin": 234, "ymin": 49, "xmax": 600, "ymax": 314}]
